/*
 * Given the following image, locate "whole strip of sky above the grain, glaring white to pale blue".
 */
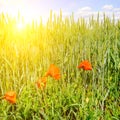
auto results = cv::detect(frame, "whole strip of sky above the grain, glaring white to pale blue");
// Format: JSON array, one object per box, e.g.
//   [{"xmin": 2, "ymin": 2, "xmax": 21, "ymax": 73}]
[{"xmin": 0, "ymin": 0, "xmax": 120, "ymax": 20}]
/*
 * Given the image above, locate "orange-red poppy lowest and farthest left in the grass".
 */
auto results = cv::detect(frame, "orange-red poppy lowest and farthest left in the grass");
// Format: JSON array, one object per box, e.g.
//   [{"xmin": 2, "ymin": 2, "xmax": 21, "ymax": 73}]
[{"xmin": 4, "ymin": 91, "xmax": 16, "ymax": 104}]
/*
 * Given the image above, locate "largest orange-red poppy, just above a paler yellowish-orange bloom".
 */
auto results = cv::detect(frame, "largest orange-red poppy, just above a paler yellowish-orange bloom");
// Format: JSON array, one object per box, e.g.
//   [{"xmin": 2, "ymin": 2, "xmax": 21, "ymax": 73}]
[{"xmin": 45, "ymin": 64, "xmax": 60, "ymax": 80}]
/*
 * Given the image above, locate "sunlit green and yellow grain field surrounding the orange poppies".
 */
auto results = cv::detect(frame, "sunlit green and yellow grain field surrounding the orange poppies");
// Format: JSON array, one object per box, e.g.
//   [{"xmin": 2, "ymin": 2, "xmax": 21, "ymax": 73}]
[{"xmin": 0, "ymin": 11, "xmax": 120, "ymax": 120}]
